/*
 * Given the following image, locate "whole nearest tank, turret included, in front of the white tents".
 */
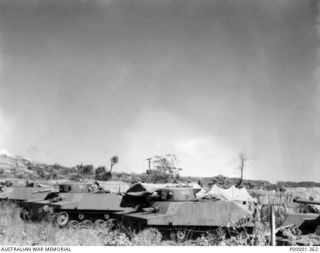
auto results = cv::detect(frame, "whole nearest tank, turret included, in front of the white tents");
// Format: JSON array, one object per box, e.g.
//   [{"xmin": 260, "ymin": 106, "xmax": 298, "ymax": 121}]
[{"xmin": 115, "ymin": 187, "xmax": 253, "ymax": 241}]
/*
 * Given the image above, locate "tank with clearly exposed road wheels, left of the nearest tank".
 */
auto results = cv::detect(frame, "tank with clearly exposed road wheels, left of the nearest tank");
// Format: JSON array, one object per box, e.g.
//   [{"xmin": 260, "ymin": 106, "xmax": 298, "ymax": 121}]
[{"xmin": 21, "ymin": 183, "xmax": 130, "ymax": 228}]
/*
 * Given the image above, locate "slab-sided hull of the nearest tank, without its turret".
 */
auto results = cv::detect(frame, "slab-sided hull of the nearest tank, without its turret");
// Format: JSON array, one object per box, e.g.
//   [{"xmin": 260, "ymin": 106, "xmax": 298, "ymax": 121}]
[{"xmin": 114, "ymin": 200, "xmax": 254, "ymax": 239}]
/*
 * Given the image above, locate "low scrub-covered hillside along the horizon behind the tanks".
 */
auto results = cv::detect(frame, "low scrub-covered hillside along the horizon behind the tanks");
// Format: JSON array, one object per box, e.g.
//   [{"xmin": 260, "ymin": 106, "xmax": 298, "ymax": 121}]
[{"xmin": 0, "ymin": 154, "xmax": 320, "ymax": 190}]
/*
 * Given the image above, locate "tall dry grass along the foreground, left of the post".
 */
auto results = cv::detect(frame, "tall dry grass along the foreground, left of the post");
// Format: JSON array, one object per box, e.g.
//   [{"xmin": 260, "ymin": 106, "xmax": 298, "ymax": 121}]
[{"xmin": 0, "ymin": 204, "xmax": 268, "ymax": 246}]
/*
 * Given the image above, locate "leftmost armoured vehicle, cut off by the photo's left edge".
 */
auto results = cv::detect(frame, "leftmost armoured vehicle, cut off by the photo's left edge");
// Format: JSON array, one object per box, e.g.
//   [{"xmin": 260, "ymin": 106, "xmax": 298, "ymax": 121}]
[{"xmin": 0, "ymin": 179, "xmax": 53, "ymax": 204}]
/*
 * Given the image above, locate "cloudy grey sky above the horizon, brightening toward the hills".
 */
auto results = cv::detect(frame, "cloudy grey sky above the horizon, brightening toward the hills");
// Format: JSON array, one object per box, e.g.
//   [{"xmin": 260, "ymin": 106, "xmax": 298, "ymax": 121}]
[{"xmin": 0, "ymin": 0, "xmax": 320, "ymax": 181}]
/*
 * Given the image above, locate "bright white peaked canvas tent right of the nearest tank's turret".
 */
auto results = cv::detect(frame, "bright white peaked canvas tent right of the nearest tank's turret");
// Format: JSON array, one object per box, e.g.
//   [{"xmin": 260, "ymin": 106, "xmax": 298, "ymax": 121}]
[{"xmin": 198, "ymin": 185, "xmax": 254, "ymax": 202}]
